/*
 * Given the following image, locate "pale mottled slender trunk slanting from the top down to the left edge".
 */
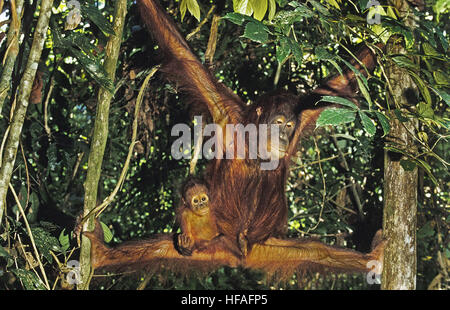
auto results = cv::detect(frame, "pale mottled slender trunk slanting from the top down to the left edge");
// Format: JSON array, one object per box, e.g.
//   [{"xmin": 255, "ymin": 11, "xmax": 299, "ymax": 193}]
[{"xmin": 0, "ymin": 0, "xmax": 53, "ymax": 223}]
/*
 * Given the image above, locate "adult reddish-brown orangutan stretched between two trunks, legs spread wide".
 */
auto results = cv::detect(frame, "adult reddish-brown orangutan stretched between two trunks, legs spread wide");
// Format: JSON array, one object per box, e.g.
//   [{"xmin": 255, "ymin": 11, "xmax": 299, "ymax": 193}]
[{"xmin": 82, "ymin": 0, "xmax": 384, "ymax": 275}]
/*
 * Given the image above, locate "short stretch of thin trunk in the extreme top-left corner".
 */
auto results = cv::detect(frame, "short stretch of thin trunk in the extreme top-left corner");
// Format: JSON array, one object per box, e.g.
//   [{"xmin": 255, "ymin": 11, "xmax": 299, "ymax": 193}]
[{"xmin": 0, "ymin": 0, "xmax": 23, "ymax": 114}]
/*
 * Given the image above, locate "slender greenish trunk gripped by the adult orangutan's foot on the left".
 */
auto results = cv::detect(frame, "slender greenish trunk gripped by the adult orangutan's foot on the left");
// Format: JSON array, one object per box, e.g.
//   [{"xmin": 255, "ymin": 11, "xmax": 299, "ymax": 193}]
[{"xmin": 78, "ymin": 0, "xmax": 127, "ymax": 289}]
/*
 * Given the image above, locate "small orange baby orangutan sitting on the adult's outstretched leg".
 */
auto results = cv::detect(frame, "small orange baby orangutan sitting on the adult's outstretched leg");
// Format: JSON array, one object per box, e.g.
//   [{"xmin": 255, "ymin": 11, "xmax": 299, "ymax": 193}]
[{"xmin": 176, "ymin": 178, "xmax": 219, "ymax": 256}]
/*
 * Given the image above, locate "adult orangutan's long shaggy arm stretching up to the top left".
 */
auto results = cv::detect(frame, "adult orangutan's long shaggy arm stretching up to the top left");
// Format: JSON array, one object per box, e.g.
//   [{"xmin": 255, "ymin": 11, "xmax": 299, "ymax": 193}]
[{"xmin": 137, "ymin": 0, "xmax": 243, "ymax": 126}]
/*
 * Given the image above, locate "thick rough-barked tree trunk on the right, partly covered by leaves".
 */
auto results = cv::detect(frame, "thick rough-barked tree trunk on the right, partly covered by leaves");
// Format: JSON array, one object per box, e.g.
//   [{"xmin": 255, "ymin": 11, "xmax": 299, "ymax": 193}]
[{"xmin": 381, "ymin": 0, "xmax": 418, "ymax": 290}]
